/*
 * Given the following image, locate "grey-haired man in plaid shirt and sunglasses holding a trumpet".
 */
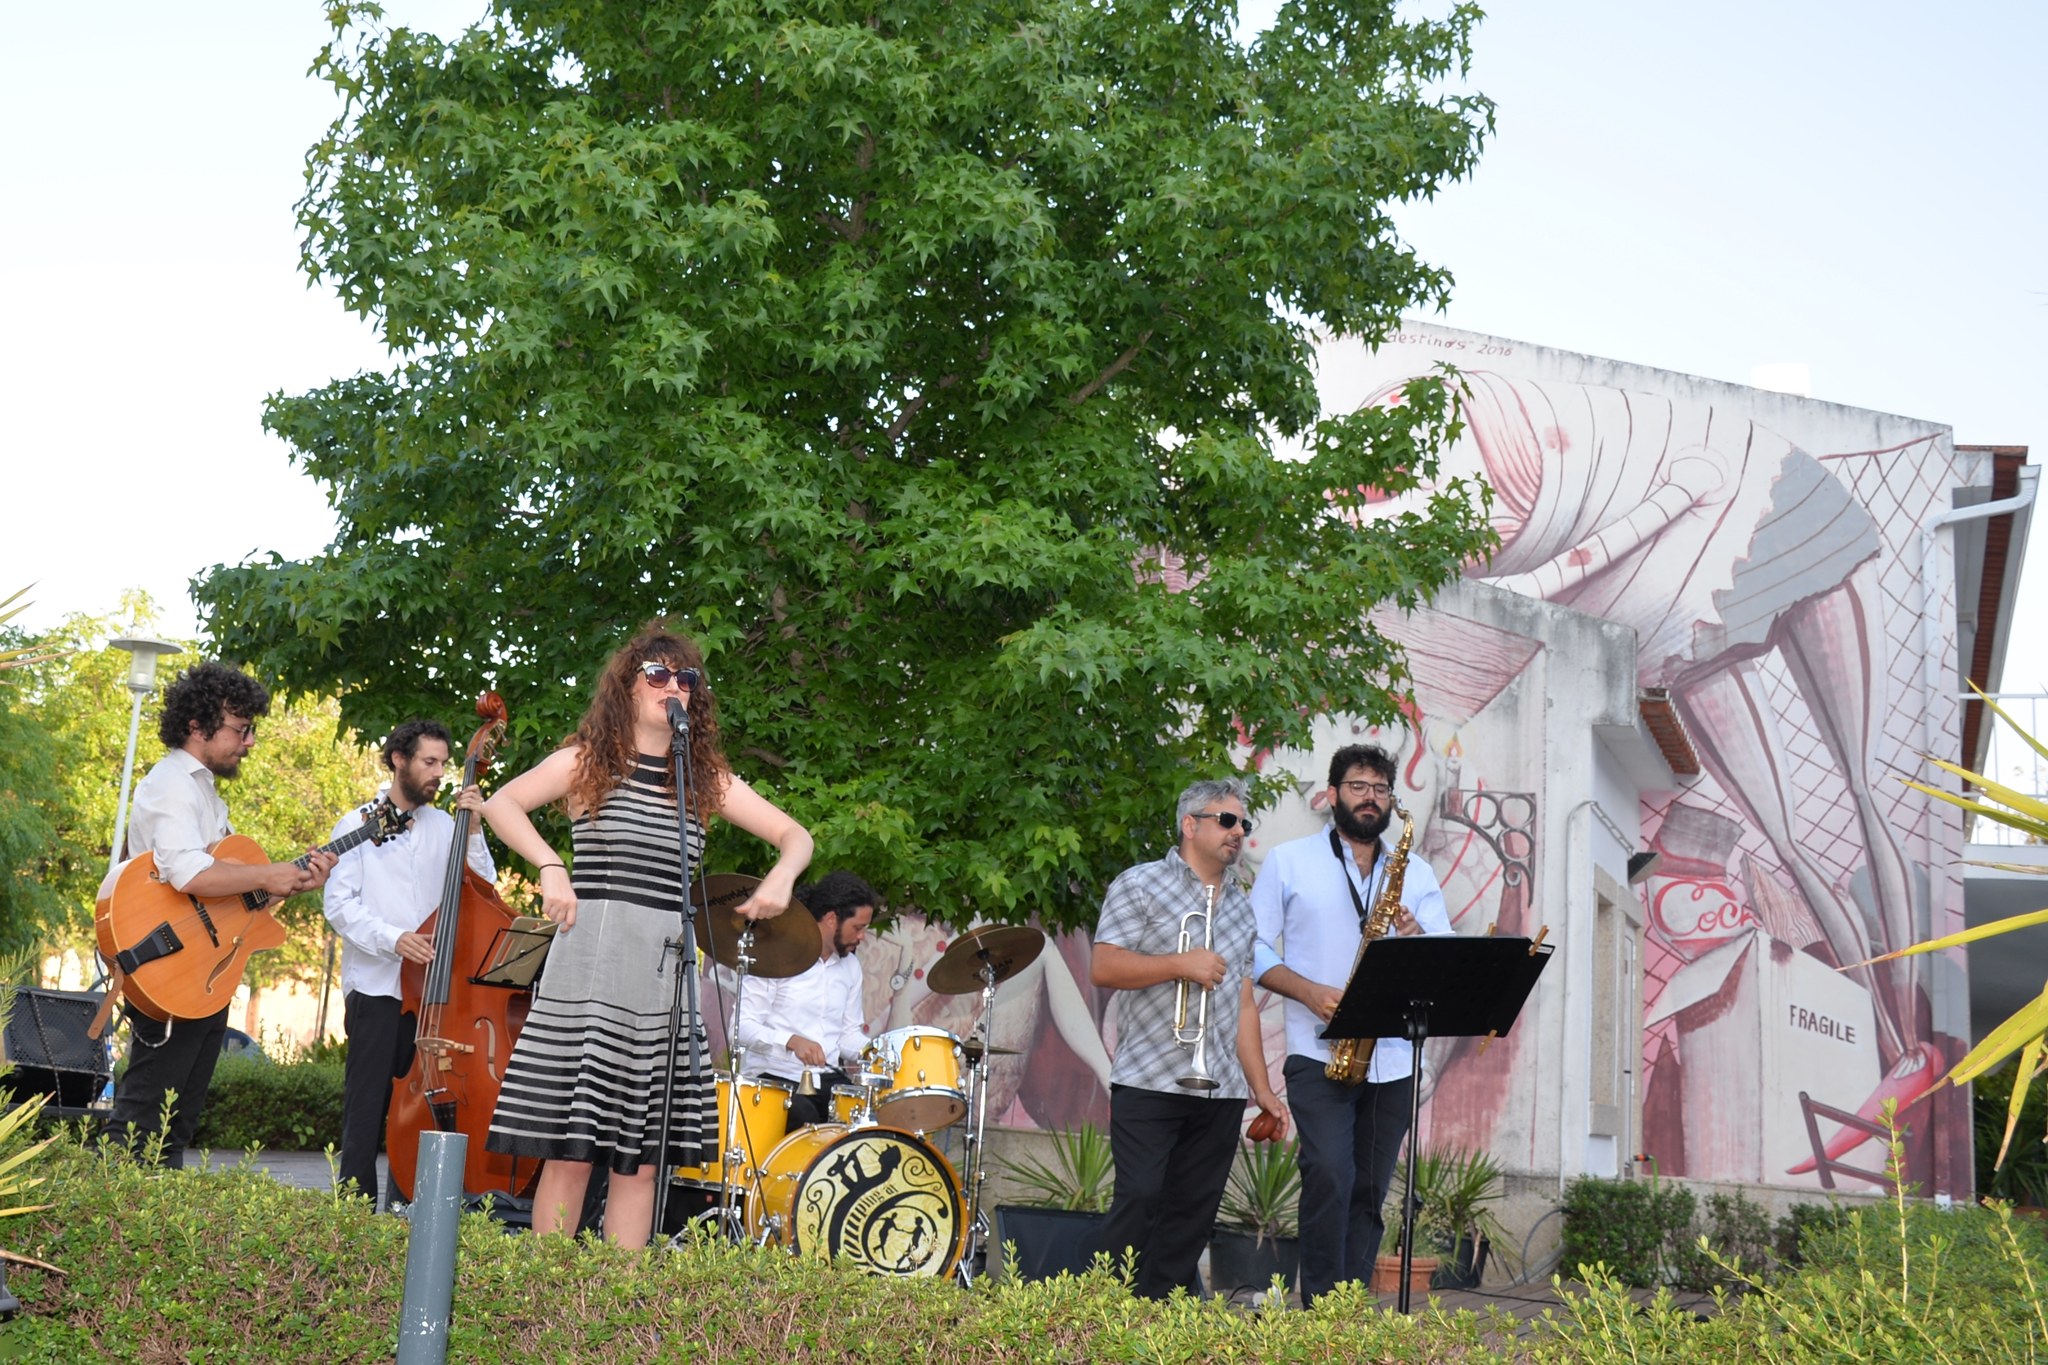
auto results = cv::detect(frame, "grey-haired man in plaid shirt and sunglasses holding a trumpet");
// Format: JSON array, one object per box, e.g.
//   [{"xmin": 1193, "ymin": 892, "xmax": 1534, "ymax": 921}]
[{"xmin": 1090, "ymin": 778, "xmax": 1286, "ymax": 1300}]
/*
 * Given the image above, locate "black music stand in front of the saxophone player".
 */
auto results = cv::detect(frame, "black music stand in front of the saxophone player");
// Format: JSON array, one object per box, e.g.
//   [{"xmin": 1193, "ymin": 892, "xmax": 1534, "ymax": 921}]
[{"xmin": 1321, "ymin": 935, "xmax": 1550, "ymax": 1312}]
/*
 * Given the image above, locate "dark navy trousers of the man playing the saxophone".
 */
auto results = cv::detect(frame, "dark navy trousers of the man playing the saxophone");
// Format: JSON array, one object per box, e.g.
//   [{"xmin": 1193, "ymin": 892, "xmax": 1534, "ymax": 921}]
[{"xmin": 1284, "ymin": 1056, "xmax": 1415, "ymax": 1308}]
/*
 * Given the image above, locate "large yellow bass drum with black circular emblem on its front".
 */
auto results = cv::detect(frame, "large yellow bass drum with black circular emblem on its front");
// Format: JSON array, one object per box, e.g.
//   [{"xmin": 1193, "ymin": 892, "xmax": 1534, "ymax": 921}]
[{"xmin": 745, "ymin": 1124, "xmax": 967, "ymax": 1277}]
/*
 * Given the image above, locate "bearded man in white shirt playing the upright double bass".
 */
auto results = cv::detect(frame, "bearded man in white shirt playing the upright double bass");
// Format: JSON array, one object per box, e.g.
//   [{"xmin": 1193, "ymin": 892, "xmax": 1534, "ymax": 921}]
[{"xmin": 322, "ymin": 720, "xmax": 498, "ymax": 1201}]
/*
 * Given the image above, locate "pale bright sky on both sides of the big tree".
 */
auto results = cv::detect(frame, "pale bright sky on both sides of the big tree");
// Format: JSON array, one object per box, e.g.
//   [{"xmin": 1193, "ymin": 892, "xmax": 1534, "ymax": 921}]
[{"xmin": 0, "ymin": 0, "xmax": 2048, "ymax": 692}]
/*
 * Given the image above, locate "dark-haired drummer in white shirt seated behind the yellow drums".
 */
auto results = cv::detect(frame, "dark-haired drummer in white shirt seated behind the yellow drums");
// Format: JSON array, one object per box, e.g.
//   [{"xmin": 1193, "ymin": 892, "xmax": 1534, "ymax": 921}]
[{"xmin": 737, "ymin": 870, "xmax": 874, "ymax": 1130}]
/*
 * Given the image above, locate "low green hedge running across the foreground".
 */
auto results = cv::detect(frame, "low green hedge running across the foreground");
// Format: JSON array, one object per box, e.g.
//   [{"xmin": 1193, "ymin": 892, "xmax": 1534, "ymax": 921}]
[{"xmin": 0, "ymin": 1138, "xmax": 2048, "ymax": 1365}]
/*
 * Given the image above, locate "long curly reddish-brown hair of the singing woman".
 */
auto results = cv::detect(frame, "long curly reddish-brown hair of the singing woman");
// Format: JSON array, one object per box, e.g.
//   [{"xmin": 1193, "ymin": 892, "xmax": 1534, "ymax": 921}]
[{"xmin": 561, "ymin": 620, "xmax": 733, "ymax": 821}]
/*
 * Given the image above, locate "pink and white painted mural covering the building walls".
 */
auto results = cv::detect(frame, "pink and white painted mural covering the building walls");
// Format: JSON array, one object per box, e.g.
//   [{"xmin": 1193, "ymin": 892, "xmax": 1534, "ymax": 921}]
[{"xmin": 707, "ymin": 325, "xmax": 1972, "ymax": 1191}]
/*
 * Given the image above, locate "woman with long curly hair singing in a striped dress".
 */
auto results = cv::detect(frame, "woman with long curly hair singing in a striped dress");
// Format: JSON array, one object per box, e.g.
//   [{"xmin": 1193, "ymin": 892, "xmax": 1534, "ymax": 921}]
[{"xmin": 483, "ymin": 622, "xmax": 811, "ymax": 1246}]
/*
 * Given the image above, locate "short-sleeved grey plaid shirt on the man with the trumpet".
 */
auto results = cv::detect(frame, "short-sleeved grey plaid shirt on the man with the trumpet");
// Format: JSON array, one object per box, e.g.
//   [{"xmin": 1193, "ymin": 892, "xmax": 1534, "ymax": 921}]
[{"xmin": 1096, "ymin": 849, "xmax": 1255, "ymax": 1099}]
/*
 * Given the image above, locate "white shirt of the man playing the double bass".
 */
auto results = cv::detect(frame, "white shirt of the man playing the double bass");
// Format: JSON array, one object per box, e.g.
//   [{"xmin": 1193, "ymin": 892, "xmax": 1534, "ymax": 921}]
[{"xmin": 322, "ymin": 806, "xmax": 498, "ymax": 999}]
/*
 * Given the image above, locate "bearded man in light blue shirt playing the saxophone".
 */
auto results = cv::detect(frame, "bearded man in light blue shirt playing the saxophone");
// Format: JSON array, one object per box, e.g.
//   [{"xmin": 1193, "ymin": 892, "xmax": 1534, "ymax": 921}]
[{"xmin": 1251, "ymin": 745, "xmax": 1450, "ymax": 1308}]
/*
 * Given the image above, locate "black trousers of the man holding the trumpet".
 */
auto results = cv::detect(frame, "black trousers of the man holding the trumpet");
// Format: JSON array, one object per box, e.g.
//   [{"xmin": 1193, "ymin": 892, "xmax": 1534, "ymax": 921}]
[{"xmin": 1102, "ymin": 1085, "xmax": 1245, "ymax": 1300}]
